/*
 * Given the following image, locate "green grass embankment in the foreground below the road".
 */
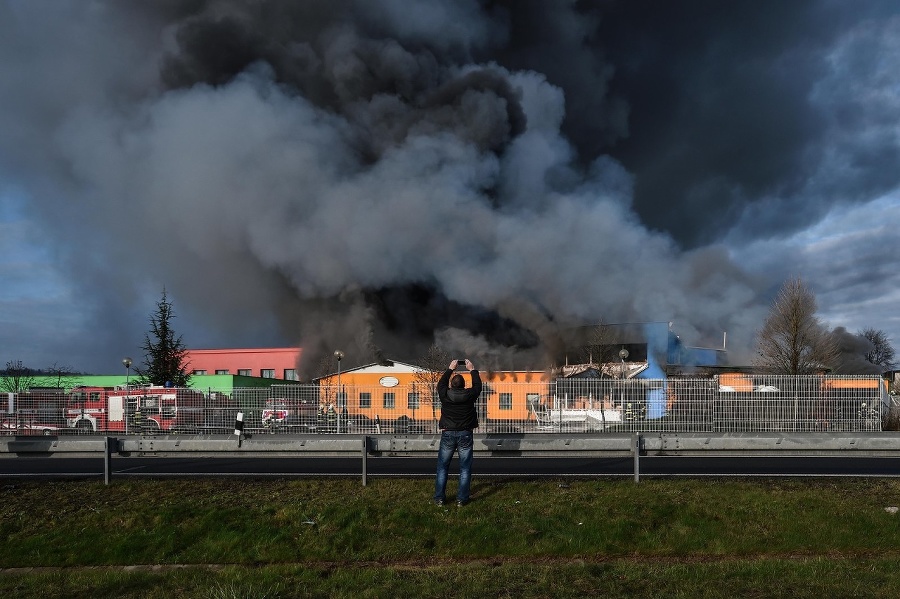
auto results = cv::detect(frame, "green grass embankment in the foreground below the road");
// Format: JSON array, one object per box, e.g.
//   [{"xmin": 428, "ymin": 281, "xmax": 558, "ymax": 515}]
[{"xmin": 0, "ymin": 478, "xmax": 900, "ymax": 599}]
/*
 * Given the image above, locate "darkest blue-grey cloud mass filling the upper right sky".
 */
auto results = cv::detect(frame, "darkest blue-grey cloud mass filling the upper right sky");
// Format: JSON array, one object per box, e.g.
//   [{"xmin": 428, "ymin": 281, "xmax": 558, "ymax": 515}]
[{"xmin": 492, "ymin": 0, "xmax": 900, "ymax": 246}]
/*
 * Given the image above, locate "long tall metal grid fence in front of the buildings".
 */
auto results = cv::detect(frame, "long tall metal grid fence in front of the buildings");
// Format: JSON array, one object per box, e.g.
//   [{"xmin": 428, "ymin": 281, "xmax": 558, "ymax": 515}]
[{"xmin": 0, "ymin": 374, "xmax": 892, "ymax": 435}]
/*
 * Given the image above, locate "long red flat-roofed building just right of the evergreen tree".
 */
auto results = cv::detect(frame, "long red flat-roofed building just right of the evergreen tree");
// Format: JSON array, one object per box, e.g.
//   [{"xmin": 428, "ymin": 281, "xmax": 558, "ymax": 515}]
[{"xmin": 186, "ymin": 347, "xmax": 302, "ymax": 381}]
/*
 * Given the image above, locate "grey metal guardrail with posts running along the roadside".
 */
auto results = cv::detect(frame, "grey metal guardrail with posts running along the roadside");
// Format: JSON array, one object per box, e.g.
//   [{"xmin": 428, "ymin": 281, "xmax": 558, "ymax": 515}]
[{"xmin": 0, "ymin": 432, "xmax": 900, "ymax": 484}]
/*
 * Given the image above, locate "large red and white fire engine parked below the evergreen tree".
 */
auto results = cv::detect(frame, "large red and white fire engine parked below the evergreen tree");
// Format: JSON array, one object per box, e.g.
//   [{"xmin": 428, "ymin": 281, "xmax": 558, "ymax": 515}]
[{"xmin": 65, "ymin": 386, "xmax": 204, "ymax": 434}]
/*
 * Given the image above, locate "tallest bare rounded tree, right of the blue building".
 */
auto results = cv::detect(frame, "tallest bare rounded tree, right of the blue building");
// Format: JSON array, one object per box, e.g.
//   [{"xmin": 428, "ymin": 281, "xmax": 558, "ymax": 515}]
[{"xmin": 757, "ymin": 277, "xmax": 839, "ymax": 374}]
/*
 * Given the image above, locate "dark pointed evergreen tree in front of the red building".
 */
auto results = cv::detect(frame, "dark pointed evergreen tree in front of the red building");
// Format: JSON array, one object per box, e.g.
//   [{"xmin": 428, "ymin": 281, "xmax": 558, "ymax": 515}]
[{"xmin": 135, "ymin": 289, "xmax": 191, "ymax": 387}]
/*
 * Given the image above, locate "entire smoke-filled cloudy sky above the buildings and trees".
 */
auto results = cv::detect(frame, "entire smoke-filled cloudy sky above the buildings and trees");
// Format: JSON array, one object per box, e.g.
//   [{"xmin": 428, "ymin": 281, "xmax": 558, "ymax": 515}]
[{"xmin": 0, "ymin": 0, "xmax": 900, "ymax": 374}]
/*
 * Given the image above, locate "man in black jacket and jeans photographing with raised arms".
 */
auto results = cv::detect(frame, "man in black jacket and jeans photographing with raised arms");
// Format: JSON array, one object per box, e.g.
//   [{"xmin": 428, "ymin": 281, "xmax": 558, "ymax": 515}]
[{"xmin": 434, "ymin": 359, "xmax": 481, "ymax": 507}]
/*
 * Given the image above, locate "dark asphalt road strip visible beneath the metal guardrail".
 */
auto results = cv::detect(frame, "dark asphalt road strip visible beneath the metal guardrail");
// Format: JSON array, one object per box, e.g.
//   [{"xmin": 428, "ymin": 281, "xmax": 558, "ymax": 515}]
[{"xmin": 0, "ymin": 456, "xmax": 900, "ymax": 479}]
